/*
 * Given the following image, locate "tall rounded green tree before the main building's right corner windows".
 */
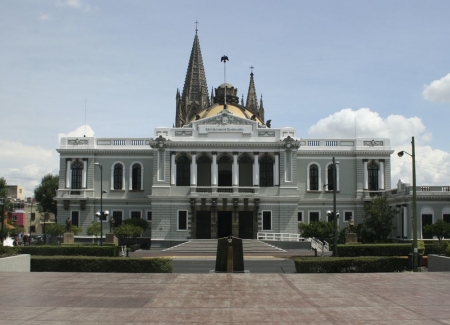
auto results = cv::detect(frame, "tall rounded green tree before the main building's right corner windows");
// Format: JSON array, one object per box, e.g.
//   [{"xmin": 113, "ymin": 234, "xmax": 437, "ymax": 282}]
[{"xmin": 358, "ymin": 196, "xmax": 395, "ymax": 243}]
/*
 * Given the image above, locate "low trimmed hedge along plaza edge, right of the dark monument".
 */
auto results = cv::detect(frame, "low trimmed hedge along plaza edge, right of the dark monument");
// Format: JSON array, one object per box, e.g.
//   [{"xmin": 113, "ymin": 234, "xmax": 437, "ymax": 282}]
[{"xmin": 294, "ymin": 256, "xmax": 408, "ymax": 273}]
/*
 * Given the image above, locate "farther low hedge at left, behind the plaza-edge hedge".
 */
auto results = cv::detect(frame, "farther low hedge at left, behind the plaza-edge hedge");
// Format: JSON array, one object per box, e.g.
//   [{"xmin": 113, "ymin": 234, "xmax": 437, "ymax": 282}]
[{"xmin": 19, "ymin": 245, "xmax": 121, "ymax": 257}]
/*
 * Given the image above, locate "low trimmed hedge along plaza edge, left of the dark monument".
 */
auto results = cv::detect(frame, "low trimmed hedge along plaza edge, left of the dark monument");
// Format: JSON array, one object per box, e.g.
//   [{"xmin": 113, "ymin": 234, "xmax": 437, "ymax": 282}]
[{"xmin": 31, "ymin": 256, "xmax": 173, "ymax": 273}]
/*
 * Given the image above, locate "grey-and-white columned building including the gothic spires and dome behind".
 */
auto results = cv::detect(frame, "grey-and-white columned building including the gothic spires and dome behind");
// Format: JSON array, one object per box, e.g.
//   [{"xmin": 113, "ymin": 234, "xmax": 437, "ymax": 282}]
[{"xmin": 56, "ymin": 32, "xmax": 448, "ymax": 241}]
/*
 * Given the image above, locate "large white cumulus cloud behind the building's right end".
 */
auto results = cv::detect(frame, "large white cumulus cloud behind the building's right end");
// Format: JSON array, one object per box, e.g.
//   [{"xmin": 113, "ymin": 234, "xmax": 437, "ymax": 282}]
[{"xmin": 308, "ymin": 108, "xmax": 450, "ymax": 187}]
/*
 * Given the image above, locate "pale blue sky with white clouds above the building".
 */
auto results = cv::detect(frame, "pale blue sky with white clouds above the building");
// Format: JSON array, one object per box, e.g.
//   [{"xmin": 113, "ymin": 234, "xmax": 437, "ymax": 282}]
[{"xmin": 0, "ymin": 0, "xmax": 450, "ymax": 195}]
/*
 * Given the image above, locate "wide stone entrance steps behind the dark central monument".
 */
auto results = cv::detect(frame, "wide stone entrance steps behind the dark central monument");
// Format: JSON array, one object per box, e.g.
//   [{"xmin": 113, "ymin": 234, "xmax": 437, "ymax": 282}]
[{"xmin": 163, "ymin": 239, "xmax": 286, "ymax": 255}]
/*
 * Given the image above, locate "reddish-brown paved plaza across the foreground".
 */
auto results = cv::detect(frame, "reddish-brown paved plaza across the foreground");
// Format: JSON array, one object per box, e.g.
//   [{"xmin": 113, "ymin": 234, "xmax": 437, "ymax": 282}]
[{"xmin": 0, "ymin": 272, "xmax": 450, "ymax": 325}]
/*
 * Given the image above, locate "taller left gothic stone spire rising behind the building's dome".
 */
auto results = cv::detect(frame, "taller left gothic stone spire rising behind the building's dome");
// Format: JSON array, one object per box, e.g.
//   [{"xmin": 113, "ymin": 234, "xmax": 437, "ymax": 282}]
[{"xmin": 175, "ymin": 28, "xmax": 210, "ymax": 127}]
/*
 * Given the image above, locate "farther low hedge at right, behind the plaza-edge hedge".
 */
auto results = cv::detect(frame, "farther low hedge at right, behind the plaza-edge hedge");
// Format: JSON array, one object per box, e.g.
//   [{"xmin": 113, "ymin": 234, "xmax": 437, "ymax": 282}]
[{"xmin": 338, "ymin": 244, "xmax": 411, "ymax": 257}]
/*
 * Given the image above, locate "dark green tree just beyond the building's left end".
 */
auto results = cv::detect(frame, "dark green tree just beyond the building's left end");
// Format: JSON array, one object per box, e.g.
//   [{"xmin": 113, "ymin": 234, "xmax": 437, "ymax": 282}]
[{"xmin": 34, "ymin": 174, "xmax": 59, "ymax": 220}]
